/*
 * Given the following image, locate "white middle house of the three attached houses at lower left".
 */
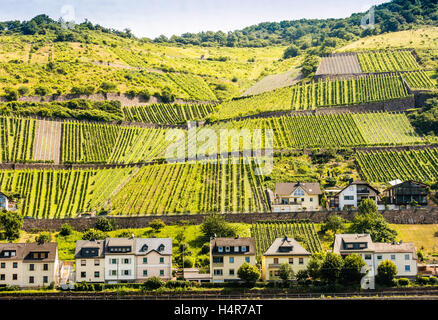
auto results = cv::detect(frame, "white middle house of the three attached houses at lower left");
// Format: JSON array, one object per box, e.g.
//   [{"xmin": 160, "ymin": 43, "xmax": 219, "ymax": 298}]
[{"xmin": 105, "ymin": 238, "xmax": 136, "ymax": 283}]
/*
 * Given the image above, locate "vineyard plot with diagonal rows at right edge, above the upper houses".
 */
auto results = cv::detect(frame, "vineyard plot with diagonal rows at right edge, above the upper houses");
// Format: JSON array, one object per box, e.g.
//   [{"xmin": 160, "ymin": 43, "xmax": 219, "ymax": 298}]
[{"xmin": 356, "ymin": 149, "xmax": 438, "ymax": 182}]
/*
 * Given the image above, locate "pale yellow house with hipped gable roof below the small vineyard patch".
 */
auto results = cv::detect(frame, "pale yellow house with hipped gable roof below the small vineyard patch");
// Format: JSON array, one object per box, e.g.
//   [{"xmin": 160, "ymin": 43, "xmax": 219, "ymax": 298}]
[{"xmin": 262, "ymin": 237, "xmax": 312, "ymax": 281}]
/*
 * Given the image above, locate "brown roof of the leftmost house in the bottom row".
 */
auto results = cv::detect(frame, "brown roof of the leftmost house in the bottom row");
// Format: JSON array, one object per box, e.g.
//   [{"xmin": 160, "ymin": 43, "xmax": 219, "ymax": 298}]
[{"xmin": 0, "ymin": 242, "xmax": 58, "ymax": 262}]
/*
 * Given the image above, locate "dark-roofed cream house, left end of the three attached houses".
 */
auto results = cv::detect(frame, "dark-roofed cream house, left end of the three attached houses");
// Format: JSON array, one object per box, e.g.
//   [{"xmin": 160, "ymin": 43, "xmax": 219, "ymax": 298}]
[{"xmin": 75, "ymin": 240, "xmax": 105, "ymax": 282}]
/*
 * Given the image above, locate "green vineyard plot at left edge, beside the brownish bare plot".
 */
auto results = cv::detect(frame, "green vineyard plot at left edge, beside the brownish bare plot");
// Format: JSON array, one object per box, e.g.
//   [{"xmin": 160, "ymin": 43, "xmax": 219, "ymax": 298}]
[{"xmin": 0, "ymin": 116, "xmax": 36, "ymax": 162}]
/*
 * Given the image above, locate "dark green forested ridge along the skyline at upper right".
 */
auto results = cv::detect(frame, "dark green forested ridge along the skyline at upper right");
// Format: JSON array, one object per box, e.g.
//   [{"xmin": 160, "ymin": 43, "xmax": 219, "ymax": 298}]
[{"xmin": 154, "ymin": 0, "xmax": 438, "ymax": 49}]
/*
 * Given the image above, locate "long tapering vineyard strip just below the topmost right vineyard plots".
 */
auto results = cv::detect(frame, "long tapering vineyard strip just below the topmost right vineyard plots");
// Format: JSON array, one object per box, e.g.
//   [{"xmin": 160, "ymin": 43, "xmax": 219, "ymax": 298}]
[{"xmin": 210, "ymin": 74, "xmax": 409, "ymax": 120}]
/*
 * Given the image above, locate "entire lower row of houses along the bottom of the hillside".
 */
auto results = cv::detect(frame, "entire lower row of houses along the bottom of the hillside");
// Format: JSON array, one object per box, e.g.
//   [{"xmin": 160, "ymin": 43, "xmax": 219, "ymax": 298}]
[{"xmin": 0, "ymin": 234, "xmax": 418, "ymax": 288}]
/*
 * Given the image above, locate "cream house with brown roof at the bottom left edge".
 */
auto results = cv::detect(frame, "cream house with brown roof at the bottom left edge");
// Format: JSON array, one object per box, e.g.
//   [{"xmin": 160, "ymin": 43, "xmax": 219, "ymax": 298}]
[{"xmin": 0, "ymin": 243, "xmax": 60, "ymax": 288}]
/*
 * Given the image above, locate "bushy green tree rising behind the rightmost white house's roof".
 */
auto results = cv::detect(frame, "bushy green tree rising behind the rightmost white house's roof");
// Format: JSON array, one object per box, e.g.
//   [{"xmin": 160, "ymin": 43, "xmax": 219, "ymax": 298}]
[{"xmin": 349, "ymin": 212, "xmax": 397, "ymax": 242}]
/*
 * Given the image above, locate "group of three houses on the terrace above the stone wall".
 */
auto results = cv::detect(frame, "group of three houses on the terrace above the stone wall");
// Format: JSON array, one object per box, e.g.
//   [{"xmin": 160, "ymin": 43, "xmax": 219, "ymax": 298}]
[{"xmin": 267, "ymin": 180, "xmax": 429, "ymax": 212}]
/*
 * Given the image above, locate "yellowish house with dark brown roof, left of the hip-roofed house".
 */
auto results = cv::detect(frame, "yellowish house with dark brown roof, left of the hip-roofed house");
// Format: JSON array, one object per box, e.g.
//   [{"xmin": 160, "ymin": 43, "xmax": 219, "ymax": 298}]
[{"xmin": 210, "ymin": 237, "xmax": 256, "ymax": 282}]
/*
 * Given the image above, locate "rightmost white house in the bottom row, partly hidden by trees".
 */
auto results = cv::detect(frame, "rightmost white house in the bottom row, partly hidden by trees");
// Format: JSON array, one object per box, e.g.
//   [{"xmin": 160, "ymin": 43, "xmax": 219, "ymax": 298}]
[{"xmin": 333, "ymin": 234, "xmax": 418, "ymax": 279}]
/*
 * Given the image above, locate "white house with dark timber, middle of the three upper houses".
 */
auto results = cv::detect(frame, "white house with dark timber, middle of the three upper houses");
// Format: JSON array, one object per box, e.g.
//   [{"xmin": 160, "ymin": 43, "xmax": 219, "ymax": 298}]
[{"xmin": 330, "ymin": 180, "xmax": 379, "ymax": 210}]
